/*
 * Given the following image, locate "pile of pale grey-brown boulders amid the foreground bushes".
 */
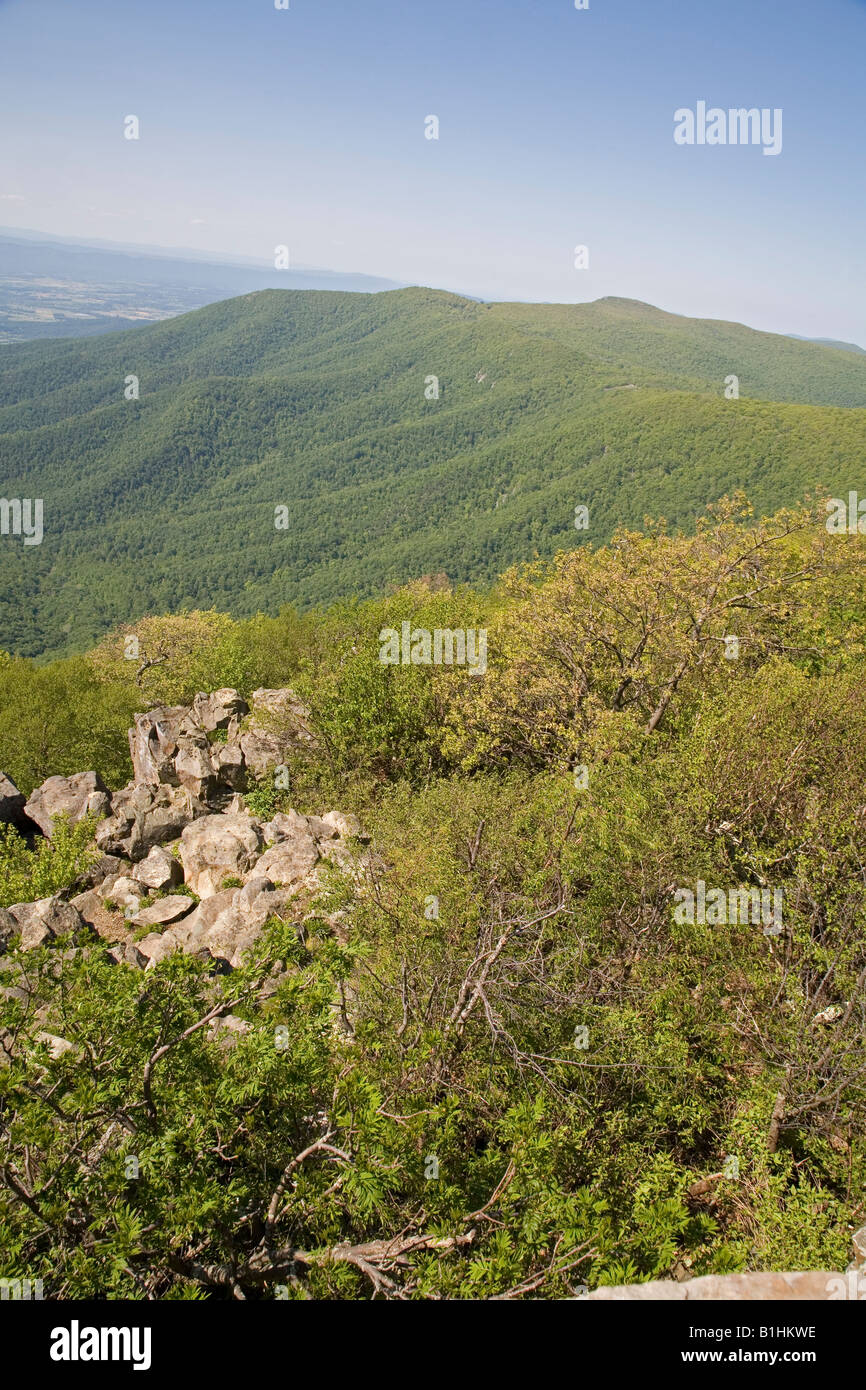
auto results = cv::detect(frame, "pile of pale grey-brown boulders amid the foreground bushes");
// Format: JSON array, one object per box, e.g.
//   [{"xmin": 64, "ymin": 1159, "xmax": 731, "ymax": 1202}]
[{"xmin": 0, "ymin": 688, "xmax": 360, "ymax": 969}]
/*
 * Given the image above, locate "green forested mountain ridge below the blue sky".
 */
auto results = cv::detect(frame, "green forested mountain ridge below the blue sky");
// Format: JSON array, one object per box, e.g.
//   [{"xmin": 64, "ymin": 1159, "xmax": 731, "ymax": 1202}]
[{"xmin": 0, "ymin": 289, "xmax": 866, "ymax": 656}]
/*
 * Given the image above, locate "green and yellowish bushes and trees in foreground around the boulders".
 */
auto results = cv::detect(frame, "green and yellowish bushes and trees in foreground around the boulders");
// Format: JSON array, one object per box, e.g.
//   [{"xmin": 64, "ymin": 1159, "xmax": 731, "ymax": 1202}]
[{"xmin": 0, "ymin": 500, "xmax": 866, "ymax": 1300}]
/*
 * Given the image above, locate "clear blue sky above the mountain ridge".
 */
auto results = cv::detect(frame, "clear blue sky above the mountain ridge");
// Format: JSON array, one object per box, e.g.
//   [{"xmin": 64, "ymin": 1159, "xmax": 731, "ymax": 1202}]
[{"xmin": 0, "ymin": 0, "xmax": 866, "ymax": 345}]
